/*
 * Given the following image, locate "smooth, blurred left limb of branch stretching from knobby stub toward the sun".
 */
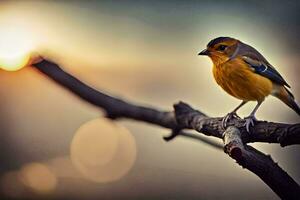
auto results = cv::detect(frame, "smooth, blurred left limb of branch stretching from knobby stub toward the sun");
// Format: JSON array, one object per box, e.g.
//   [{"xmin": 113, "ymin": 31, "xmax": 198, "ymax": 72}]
[{"xmin": 34, "ymin": 60, "xmax": 177, "ymax": 129}]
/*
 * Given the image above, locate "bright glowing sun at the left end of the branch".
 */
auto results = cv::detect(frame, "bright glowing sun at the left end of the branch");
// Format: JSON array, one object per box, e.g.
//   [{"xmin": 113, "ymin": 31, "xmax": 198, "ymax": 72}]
[{"xmin": 0, "ymin": 27, "xmax": 34, "ymax": 71}]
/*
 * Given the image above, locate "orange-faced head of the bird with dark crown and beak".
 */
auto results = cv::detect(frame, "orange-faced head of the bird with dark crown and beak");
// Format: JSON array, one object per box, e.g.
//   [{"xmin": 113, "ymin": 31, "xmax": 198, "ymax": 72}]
[{"xmin": 198, "ymin": 37, "xmax": 240, "ymax": 65}]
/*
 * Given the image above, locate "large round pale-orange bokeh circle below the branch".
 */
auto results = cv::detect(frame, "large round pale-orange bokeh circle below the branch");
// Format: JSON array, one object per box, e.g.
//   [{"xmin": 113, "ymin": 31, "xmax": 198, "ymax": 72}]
[{"xmin": 71, "ymin": 118, "xmax": 136, "ymax": 183}]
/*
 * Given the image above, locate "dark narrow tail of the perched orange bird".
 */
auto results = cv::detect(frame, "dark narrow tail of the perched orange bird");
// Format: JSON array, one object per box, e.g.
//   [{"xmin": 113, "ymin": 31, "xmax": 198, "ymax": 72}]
[{"xmin": 274, "ymin": 86, "xmax": 300, "ymax": 115}]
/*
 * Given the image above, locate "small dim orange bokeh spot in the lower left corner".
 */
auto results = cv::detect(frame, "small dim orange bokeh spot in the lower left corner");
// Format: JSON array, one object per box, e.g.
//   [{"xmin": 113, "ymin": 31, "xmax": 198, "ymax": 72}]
[{"xmin": 19, "ymin": 163, "xmax": 57, "ymax": 194}]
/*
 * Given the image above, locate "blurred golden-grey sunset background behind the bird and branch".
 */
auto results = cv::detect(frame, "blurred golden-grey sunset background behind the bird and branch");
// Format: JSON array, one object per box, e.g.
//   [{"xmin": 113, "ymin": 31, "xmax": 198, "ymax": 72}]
[{"xmin": 0, "ymin": 0, "xmax": 300, "ymax": 199}]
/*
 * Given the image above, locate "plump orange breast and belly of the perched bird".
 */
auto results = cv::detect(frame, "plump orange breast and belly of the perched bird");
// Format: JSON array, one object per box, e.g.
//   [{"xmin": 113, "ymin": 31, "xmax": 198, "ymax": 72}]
[{"xmin": 213, "ymin": 58, "xmax": 273, "ymax": 101}]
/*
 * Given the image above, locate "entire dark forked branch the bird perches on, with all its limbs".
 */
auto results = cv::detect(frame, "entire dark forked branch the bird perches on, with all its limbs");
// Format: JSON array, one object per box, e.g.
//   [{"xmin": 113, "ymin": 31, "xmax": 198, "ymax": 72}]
[{"xmin": 33, "ymin": 60, "xmax": 300, "ymax": 198}]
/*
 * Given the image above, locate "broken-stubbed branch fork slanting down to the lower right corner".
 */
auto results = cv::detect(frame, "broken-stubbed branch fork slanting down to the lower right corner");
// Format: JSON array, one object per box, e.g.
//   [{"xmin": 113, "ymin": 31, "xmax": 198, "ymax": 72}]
[{"xmin": 224, "ymin": 126, "xmax": 300, "ymax": 199}]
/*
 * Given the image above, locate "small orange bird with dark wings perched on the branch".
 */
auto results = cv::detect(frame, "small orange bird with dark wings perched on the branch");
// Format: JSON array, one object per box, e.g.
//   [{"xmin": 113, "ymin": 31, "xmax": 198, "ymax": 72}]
[{"xmin": 198, "ymin": 37, "xmax": 300, "ymax": 133}]
